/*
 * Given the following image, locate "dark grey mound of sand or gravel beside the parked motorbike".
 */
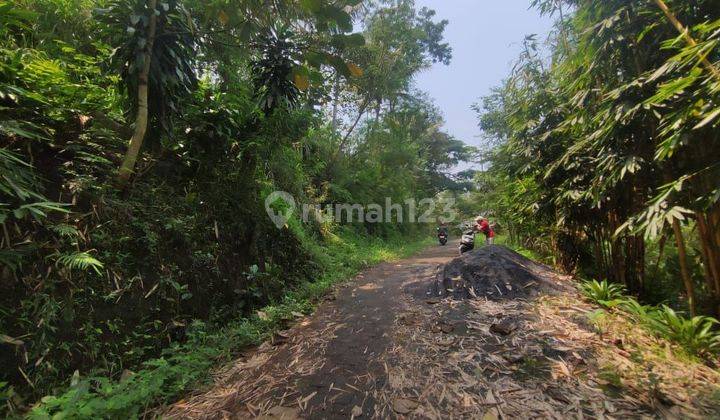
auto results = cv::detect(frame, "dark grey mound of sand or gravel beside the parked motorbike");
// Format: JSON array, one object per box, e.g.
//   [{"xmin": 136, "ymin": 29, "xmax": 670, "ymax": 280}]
[{"xmin": 428, "ymin": 245, "xmax": 571, "ymax": 300}]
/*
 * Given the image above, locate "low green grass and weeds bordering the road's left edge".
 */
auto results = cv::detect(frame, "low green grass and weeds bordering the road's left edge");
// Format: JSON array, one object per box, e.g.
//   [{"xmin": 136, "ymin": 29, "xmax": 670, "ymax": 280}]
[{"xmin": 29, "ymin": 230, "xmax": 432, "ymax": 419}]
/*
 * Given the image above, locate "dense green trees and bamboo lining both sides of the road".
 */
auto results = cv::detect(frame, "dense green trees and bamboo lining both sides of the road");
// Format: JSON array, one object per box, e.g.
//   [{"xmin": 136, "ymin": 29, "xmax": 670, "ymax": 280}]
[{"xmin": 0, "ymin": 0, "xmax": 720, "ymax": 418}]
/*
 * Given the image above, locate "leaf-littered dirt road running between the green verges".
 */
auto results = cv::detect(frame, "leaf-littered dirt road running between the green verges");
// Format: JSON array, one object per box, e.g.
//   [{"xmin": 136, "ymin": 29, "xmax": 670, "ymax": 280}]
[{"xmin": 165, "ymin": 245, "xmax": 717, "ymax": 420}]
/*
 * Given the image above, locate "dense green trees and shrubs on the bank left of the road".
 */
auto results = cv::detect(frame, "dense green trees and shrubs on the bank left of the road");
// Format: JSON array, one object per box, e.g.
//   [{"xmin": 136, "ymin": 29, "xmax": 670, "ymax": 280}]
[{"xmin": 0, "ymin": 0, "xmax": 470, "ymax": 416}]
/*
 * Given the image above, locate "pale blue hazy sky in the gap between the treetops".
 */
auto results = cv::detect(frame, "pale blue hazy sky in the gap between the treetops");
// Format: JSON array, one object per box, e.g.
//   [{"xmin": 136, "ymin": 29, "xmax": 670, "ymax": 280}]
[{"xmin": 416, "ymin": 0, "xmax": 552, "ymax": 151}]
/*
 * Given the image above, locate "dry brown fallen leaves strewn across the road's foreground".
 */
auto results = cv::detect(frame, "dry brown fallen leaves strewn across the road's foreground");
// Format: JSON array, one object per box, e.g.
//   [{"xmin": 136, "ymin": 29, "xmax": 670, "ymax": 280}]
[{"xmin": 163, "ymin": 251, "xmax": 720, "ymax": 420}]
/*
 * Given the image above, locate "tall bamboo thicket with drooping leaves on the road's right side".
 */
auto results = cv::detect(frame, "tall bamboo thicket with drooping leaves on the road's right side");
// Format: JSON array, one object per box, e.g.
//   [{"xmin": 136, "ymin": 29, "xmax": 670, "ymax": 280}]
[{"xmin": 472, "ymin": 0, "xmax": 720, "ymax": 318}]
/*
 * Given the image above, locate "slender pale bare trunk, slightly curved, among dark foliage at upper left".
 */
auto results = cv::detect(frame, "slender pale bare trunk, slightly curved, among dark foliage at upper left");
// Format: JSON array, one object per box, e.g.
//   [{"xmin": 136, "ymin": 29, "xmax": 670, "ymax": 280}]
[{"xmin": 118, "ymin": 0, "xmax": 157, "ymax": 186}]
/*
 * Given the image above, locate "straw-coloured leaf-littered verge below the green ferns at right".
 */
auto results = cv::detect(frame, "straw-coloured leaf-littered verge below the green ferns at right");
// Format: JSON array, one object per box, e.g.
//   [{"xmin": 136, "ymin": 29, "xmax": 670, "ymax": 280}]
[{"xmin": 537, "ymin": 295, "xmax": 720, "ymax": 418}]
